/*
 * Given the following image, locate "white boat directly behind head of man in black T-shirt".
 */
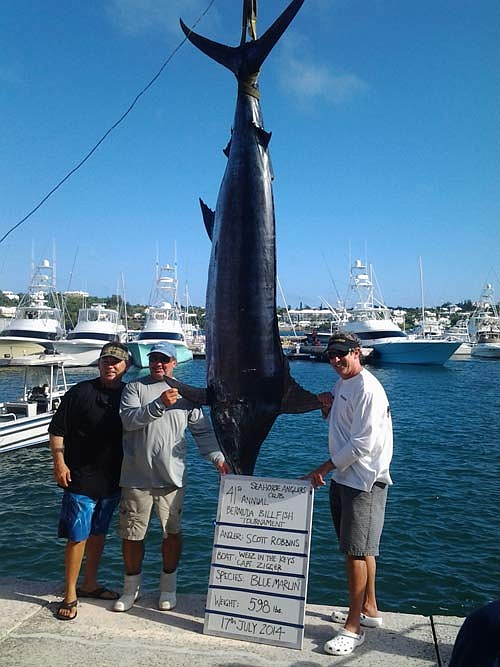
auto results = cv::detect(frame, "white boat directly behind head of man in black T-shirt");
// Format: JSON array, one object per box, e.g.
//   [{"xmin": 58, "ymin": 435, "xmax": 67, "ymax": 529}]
[{"xmin": 54, "ymin": 303, "xmax": 127, "ymax": 366}]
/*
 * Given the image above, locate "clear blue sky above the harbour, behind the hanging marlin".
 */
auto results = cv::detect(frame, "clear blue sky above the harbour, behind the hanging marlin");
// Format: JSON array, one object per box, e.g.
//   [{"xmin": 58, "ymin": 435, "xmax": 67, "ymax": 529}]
[{"xmin": 0, "ymin": 0, "xmax": 500, "ymax": 307}]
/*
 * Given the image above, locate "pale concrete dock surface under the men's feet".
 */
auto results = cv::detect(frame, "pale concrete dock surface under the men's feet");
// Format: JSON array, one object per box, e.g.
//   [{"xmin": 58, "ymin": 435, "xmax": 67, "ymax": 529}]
[{"xmin": 0, "ymin": 579, "xmax": 464, "ymax": 667}]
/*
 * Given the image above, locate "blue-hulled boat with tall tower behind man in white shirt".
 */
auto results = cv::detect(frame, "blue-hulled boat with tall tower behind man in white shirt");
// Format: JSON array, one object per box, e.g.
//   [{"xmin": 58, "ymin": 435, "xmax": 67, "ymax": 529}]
[{"xmin": 341, "ymin": 259, "xmax": 460, "ymax": 365}]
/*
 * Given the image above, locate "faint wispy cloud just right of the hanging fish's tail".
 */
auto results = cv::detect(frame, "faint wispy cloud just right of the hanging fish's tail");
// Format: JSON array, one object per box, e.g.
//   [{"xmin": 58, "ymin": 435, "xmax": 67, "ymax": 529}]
[{"xmin": 280, "ymin": 32, "xmax": 369, "ymax": 104}]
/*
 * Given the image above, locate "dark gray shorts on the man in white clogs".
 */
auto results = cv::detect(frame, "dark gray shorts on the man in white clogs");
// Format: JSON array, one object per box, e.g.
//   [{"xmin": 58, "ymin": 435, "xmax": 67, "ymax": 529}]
[{"xmin": 330, "ymin": 480, "xmax": 388, "ymax": 556}]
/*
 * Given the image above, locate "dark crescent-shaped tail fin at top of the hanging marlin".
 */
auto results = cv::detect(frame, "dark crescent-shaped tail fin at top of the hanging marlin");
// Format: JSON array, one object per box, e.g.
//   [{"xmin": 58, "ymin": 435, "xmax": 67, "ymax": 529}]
[{"xmin": 180, "ymin": 0, "xmax": 304, "ymax": 81}]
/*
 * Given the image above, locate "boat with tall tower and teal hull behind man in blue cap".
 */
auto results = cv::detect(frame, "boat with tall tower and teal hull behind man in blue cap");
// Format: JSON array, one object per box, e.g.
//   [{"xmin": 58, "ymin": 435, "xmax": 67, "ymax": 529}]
[{"xmin": 128, "ymin": 264, "xmax": 193, "ymax": 368}]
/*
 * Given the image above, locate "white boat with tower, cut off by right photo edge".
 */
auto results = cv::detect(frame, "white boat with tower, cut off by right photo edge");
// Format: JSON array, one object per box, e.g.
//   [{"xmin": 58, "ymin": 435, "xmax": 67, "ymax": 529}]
[{"xmin": 469, "ymin": 283, "xmax": 500, "ymax": 358}]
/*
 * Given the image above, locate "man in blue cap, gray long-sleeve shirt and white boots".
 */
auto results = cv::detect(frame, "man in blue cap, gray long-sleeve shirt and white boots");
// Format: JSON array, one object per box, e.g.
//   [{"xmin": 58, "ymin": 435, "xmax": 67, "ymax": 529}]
[{"xmin": 113, "ymin": 341, "xmax": 229, "ymax": 611}]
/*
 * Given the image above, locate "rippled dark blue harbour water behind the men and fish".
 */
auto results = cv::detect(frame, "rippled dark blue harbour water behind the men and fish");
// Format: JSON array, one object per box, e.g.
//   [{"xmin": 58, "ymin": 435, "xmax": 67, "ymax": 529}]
[{"xmin": 0, "ymin": 359, "xmax": 500, "ymax": 616}]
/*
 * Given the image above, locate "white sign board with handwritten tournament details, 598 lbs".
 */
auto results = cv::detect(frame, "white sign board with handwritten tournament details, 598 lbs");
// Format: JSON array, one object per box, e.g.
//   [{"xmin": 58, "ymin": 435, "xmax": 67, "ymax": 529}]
[{"xmin": 203, "ymin": 475, "xmax": 314, "ymax": 648}]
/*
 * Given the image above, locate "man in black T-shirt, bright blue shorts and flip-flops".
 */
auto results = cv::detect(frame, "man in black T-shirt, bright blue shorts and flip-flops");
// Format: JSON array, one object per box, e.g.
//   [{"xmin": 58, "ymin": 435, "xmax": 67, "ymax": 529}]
[{"xmin": 49, "ymin": 343, "xmax": 130, "ymax": 621}]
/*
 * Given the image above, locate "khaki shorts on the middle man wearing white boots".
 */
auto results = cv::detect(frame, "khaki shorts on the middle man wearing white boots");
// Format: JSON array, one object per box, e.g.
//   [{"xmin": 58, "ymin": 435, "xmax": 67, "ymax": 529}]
[{"xmin": 118, "ymin": 486, "xmax": 185, "ymax": 541}]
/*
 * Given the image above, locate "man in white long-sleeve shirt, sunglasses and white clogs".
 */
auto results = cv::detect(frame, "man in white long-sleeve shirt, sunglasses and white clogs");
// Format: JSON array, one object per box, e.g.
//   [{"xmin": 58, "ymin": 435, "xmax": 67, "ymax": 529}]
[{"xmin": 307, "ymin": 333, "xmax": 392, "ymax": 655}]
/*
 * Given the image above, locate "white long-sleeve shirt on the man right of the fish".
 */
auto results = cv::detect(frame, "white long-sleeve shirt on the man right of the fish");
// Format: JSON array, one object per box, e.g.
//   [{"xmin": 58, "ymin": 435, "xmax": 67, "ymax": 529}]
[{"xmin": 328, "ymin": 368, "xmax": 392, "ymax": 491}]
